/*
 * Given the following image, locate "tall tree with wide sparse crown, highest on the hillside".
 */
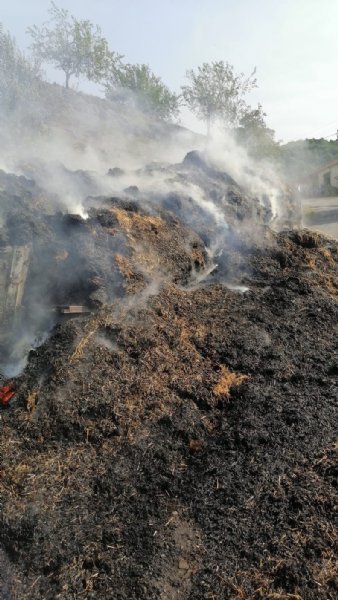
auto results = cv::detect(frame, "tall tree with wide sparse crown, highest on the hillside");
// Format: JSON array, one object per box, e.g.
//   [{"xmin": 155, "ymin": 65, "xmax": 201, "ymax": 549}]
[{"xmin": 28, "ymin": 2, "xmax": 121, "ymax": 88}]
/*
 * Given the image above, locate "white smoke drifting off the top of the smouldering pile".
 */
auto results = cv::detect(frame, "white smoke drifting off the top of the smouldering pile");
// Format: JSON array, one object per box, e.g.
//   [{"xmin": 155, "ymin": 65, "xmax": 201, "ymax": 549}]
[{"xmin": 0, "ymin": 76, "xmax": 290, "ymax": 373}]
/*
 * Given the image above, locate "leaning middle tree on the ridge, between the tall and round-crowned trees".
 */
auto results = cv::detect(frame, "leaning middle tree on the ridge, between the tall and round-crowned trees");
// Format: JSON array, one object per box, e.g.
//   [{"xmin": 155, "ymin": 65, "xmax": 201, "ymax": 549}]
[{"xmin": 106, "ymin": 64, "xmax": 180, "ymax": 120}]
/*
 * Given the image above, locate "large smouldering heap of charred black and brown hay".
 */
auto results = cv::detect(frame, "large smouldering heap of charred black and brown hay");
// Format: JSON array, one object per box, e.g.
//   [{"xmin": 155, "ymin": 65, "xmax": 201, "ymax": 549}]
[{"xmin": 0, "ymin": 152, "xmax": 338, "ymax": 600}]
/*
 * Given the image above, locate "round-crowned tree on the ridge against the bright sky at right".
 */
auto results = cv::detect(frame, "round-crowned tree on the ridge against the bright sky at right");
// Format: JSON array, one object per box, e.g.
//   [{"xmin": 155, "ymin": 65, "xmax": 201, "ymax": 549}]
[{"xmin": 182, "ymin": 61, "xmax": 257, "ymax": 135}]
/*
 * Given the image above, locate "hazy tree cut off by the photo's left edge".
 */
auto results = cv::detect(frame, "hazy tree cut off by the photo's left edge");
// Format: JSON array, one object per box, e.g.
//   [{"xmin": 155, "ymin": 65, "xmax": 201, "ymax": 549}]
[{"xmin": 0, "ymin": 24, "xmax": 40, "ymax": 114}]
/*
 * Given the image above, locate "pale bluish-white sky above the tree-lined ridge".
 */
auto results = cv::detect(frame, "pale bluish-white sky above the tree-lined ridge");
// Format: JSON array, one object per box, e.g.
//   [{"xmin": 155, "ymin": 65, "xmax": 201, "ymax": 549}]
[{"xmin": 0, "ymin": 0, "xmax": 338, "ymax": 141}]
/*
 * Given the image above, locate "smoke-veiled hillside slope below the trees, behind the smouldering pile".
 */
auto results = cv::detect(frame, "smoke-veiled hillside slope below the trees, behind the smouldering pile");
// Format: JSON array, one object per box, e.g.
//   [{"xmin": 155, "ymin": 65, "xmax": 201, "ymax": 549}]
[{"xmin": 0, "ymin": 82, "xmax": 202, "ymax": 172}]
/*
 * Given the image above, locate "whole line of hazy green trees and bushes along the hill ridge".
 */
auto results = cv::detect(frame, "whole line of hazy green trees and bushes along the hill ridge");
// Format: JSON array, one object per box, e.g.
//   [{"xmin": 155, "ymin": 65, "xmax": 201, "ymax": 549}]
[{"xmin": 0, "ymin": 2, "xmax": 338, "ymax": 178}]
